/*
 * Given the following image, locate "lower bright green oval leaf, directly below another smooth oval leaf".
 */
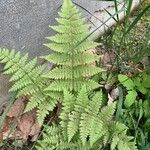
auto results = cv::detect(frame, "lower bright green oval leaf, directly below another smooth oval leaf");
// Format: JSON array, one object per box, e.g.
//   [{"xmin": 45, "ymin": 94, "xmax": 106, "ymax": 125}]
[{"xmin": 124, "ymin": 90, "xmax": 137, "ymax": 108}]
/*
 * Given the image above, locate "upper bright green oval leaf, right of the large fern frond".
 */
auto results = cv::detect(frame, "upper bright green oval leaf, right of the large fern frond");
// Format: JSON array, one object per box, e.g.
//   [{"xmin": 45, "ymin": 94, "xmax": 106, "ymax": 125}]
[{"xmin": 118, "ymin": 74, "xmax": 135, "ymax": 90}]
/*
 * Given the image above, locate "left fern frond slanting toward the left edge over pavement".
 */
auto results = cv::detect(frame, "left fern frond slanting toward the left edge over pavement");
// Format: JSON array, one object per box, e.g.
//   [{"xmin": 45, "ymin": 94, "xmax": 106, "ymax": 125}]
[{"xmin": 0, "ymin": 49, "xmax": 58, "ymax": 124}]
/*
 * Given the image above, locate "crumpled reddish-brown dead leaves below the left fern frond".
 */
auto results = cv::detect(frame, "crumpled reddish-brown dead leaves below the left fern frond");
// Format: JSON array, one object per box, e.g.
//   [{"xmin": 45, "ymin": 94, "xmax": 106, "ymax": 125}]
[{"xmin": 0, "ymin": 97, "xmax": 41, "ymax": 143}]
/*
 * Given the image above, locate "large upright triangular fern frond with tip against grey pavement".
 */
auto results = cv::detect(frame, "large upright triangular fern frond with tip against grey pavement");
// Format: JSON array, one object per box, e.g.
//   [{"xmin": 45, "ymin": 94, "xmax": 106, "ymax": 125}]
[{"xmin": 43, "ymin": 0, "xmax": 103, "ymax": 95}]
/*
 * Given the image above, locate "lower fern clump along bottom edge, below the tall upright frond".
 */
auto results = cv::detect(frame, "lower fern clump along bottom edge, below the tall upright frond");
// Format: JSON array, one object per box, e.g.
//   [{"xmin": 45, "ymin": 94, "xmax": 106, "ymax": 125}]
[{"xmin": 36, "ymin": 87, "xmax": 136, "ymax": 150}]
